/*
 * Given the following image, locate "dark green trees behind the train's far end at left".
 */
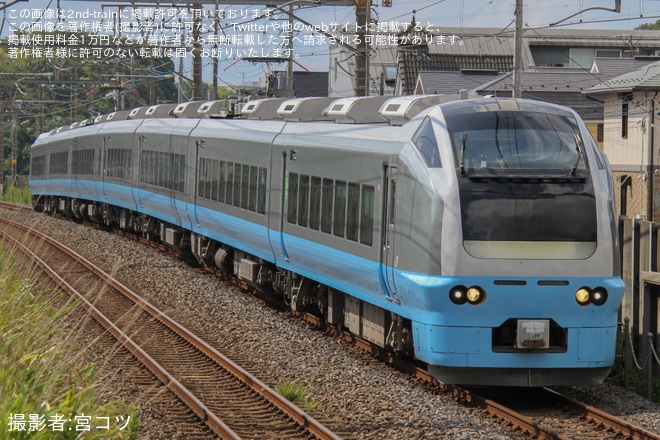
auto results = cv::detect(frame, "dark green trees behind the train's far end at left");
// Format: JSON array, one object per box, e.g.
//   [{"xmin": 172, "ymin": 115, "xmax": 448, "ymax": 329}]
[{"xmin": 0, "ymin": 32, "xmax": 177, "ymax": 180}]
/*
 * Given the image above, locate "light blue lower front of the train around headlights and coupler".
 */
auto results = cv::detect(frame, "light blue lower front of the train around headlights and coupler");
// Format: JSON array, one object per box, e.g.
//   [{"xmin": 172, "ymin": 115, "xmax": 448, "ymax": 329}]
[{"xmin": 412, "ymin": 277, "xmax": 624, "ymax": 386}]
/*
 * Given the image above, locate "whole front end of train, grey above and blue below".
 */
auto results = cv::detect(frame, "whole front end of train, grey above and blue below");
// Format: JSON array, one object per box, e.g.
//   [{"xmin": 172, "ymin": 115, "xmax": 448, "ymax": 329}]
[{"xmin": 413, "ymin": 99, "xmax": 624, "ymax": 387}]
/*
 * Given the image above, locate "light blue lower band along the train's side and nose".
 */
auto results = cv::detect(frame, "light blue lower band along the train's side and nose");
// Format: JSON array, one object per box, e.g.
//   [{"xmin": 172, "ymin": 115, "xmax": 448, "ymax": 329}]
[{"xmin": 31, "ymin": 180, "xmax": 624, "ymax": 386}]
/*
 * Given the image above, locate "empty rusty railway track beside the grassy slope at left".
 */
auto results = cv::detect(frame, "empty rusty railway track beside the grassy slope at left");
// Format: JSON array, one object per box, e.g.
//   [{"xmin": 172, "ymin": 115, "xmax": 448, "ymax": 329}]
[{"xmin": 1, "ymin": 211, "xmax": 338, "ymax": 439}]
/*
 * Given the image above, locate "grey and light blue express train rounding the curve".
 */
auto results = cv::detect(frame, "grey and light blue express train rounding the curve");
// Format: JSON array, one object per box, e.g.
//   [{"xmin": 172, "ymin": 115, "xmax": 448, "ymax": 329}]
[{"xmin": 30, "ymin": 93, "xmax": 624, "ymax": 387}]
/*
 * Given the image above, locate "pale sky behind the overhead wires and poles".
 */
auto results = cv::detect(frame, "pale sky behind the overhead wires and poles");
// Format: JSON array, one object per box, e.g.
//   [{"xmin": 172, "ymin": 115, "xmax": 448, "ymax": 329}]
[{"xmin": 0, "ymin": 0, "xmax": 660, "ymax": 85}]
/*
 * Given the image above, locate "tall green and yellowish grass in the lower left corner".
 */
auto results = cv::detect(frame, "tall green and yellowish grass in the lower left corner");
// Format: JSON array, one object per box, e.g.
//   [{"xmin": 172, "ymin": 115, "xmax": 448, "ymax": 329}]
[{"xmin": 0, "ymin": 243, "xmax": 137, "ymax": 440}]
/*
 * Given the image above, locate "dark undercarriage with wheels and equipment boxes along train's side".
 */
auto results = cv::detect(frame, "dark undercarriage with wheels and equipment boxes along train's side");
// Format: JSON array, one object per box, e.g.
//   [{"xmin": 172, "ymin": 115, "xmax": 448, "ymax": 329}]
[{"xmin": 33, "ymin": 196, "xmax": 414, "ymax": 357}]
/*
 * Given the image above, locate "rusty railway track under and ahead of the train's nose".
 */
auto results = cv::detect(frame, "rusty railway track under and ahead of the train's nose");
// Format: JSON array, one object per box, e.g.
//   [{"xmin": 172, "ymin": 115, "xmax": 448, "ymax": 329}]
[{"xmin": 0, "ymin": 201, "xmax": 660, "ymax": 440}]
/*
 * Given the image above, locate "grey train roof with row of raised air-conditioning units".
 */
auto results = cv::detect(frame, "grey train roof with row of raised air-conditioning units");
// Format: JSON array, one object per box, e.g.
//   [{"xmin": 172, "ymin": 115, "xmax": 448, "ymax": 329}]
[{"xmin": 35, "ymin": 93, "xmax": 573, "ymax": 149}]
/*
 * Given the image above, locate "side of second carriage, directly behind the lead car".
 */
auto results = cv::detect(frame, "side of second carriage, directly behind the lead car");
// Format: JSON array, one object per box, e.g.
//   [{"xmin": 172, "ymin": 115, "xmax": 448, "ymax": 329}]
[{"xmin": 189, "ymin": 119, "xmax": 284, "ymax": 261}]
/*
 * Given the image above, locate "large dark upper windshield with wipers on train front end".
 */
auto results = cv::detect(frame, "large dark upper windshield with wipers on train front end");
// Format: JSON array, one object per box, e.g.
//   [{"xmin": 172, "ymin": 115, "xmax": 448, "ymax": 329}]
[{"xmin": 447, "ymin": 111, "xmax": 586, "ymax": 173}]
